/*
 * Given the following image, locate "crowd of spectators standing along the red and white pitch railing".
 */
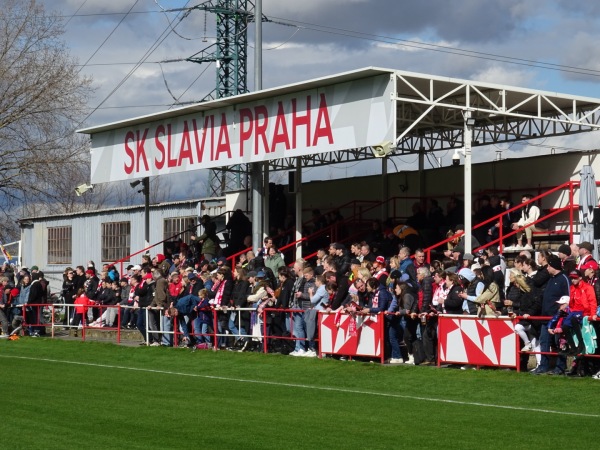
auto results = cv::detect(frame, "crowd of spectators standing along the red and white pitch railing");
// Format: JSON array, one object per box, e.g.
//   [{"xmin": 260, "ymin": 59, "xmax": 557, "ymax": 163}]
[{"xmin": 0, "ymin": 205, "xmax": 600, "ymax": 375}]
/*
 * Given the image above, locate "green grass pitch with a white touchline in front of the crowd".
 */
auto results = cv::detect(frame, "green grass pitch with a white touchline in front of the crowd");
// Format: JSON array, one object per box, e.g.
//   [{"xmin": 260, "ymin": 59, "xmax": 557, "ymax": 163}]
[{"xmin": 0, "ymin": 338, "xmax": 600, "ymax": 449}]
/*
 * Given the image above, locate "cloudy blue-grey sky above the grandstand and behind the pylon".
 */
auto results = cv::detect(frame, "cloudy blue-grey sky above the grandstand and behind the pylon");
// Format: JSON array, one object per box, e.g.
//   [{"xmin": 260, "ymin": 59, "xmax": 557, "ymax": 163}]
[{"xmin": 39, "ymin": 0, "xmax": 600, "ymax": 186}]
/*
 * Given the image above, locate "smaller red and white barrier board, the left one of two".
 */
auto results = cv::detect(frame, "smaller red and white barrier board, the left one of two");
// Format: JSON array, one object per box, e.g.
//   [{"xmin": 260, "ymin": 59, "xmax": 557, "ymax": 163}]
[{"xmin": 319, "ymin": 314, "xmax": 385, "ymax": 360}]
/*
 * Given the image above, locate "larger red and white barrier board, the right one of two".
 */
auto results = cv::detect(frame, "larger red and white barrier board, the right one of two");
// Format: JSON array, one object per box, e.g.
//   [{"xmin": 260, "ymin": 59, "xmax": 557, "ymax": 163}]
[{"xmin": 438, "ymin": 315, "xmax": 518, "ymax": 367}]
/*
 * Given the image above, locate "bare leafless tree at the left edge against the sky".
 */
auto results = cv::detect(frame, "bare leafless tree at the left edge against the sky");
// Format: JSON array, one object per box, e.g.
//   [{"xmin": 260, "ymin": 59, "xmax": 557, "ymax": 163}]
[{"xmin": 0, "ymin": 0, "xmax": 91, "ymax": 243}]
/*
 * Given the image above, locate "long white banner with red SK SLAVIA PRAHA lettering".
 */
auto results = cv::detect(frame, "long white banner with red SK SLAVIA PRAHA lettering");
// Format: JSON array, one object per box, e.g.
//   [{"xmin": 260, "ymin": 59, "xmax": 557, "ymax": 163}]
[{"xmin": 91, "ymin": 74, "xmax": 395, "ymax": 184}]
